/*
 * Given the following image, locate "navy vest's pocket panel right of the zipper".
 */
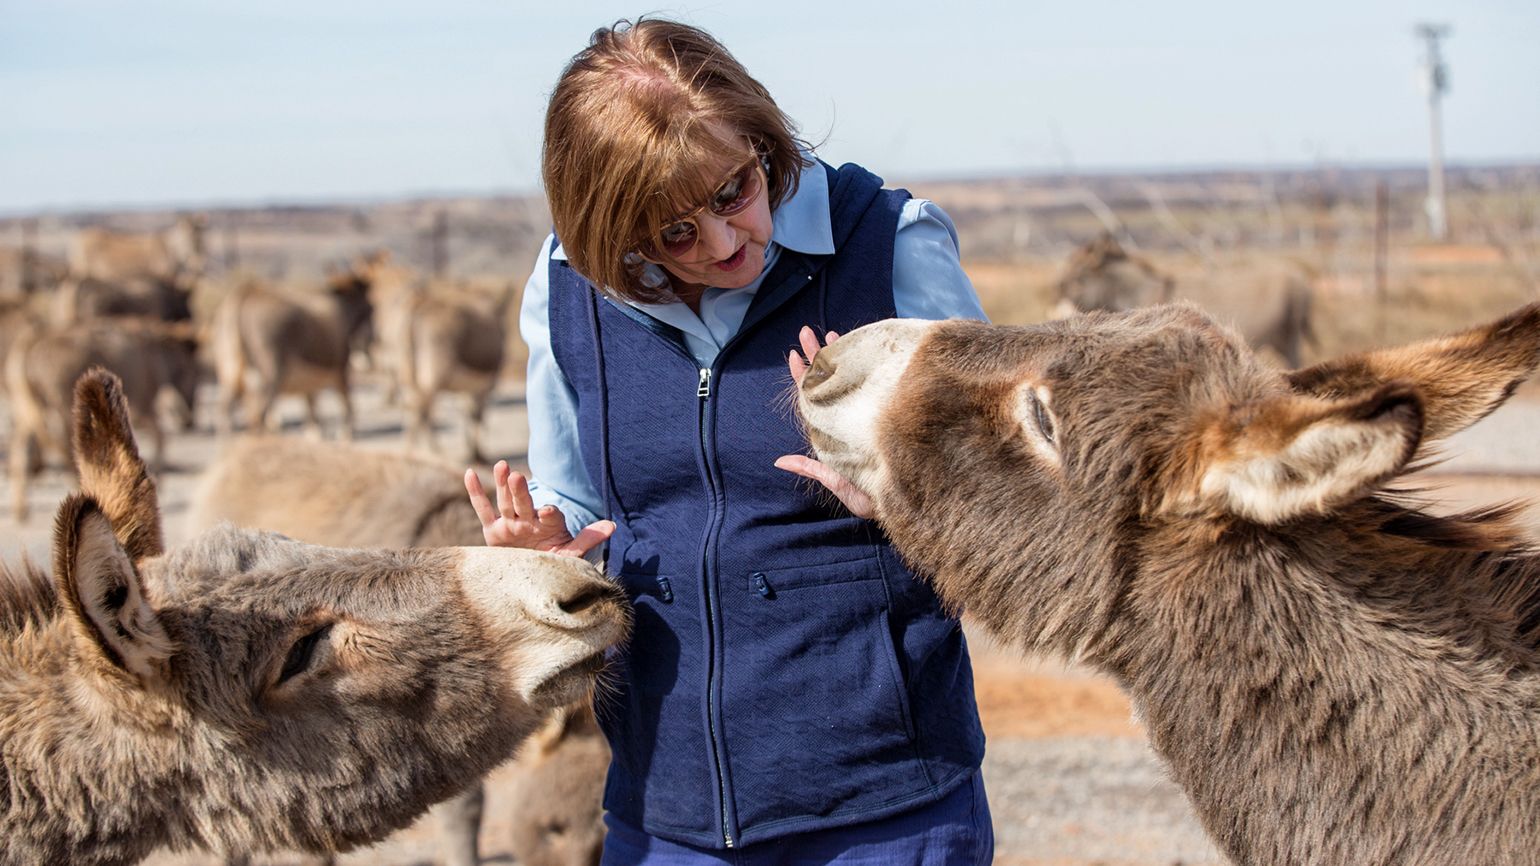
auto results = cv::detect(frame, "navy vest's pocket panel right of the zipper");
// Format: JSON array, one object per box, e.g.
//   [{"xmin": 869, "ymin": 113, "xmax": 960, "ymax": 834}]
[{"xmin": 721, "ymin": 558, "xmax": 926, "ymax": 821}]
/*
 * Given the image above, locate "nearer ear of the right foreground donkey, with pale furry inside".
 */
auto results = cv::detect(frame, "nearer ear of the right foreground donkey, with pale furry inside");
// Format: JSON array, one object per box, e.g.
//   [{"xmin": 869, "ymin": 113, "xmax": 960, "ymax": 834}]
[{"xmin": 1197, "ymin": 382, "xmax": 1423, "ymax": 524}]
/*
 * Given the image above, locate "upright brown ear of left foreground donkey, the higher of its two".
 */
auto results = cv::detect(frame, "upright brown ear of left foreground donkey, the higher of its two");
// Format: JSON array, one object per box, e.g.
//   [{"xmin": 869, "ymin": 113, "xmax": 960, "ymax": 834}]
[{"xmin": 72, "ymin": 367, "xmax": 165, "ymax": 562}]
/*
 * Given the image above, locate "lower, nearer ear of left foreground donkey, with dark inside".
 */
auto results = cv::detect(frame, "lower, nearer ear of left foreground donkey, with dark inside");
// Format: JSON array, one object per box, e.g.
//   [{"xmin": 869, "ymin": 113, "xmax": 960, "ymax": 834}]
[{"xmin": 54, "ymin": 495, "xmax": 172, "ymax": 683}]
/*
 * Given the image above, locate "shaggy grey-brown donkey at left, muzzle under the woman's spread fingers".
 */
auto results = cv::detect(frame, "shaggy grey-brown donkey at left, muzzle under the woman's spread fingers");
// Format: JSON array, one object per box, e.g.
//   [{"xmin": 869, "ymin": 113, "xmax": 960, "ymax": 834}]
[{"xmin": 0, "ymin": 371, "xmax": 628, "ymax": 864}]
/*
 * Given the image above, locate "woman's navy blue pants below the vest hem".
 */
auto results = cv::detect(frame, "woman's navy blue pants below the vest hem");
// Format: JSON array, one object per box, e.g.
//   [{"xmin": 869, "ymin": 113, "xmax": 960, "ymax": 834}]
[{"xmin": 601, "ymin": 772, "xmax": 995, "ymax": 866}]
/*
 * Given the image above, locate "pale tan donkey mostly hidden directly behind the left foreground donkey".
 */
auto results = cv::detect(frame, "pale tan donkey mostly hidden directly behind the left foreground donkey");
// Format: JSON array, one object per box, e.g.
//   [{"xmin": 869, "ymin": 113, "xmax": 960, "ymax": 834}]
[{"xmin": 186, "ymin": 436, "xmax": 610, "ymax": 866}]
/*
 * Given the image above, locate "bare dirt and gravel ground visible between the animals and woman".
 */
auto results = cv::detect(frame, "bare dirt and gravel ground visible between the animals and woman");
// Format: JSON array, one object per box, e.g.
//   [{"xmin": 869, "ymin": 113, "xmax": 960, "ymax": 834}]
[{"xmin": 12, "ymin": 363, "xmax": 1540, "ymax": 866}]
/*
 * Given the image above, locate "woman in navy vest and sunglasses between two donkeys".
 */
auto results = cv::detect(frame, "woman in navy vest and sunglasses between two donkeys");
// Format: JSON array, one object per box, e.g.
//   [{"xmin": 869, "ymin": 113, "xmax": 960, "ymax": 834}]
[{"xmin": 465, "ymin": 20, "xmax": 993, "ymax": 866}]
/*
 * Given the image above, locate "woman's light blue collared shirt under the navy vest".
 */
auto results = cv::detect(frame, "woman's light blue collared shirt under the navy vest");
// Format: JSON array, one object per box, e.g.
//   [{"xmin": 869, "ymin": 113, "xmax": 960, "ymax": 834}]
[{"xmin": 519, "ymin": 160, "xmax": 984, "ymax": 535}]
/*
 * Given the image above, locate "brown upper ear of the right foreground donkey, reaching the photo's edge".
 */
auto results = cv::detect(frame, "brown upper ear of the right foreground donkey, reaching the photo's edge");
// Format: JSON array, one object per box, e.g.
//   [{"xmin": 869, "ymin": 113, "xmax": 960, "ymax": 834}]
[{"xmin": 1289, "ymin": 304, "xmax": 1540, "ymax": 441}]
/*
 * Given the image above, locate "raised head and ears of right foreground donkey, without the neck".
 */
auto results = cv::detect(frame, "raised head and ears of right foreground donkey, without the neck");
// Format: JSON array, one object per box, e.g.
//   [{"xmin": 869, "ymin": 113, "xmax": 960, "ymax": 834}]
[{"xmin": 798, "ymin": 305, "xmax": 1540, "ymax": 652}]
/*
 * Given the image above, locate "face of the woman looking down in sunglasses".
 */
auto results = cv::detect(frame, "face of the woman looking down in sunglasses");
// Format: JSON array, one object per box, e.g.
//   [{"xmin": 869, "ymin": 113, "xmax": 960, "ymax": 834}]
[{"xmin": 647, "ymin": 145, "xmax": 773, "ymax": 294}]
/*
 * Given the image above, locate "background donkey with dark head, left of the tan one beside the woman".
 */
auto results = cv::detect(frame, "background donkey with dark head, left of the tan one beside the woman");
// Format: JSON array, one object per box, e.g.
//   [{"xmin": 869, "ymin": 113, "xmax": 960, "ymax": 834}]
[{"xmin": 209, "ymin": 265, "xmax": 371, "ymax": 439}]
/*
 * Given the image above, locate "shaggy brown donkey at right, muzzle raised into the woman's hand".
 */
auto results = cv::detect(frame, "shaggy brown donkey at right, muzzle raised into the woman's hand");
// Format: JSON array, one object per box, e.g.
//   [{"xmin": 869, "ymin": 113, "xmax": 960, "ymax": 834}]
[{"xmin": 793, "ymin": 305, "xmax": 1540, "ymax": 866}]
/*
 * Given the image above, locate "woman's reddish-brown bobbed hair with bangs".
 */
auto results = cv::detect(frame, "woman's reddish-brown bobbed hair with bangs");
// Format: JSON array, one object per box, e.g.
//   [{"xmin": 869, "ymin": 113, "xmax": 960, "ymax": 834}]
[{"xmin": 542, "ymin": 18, "xmax": 809, "ymax": 302}]
